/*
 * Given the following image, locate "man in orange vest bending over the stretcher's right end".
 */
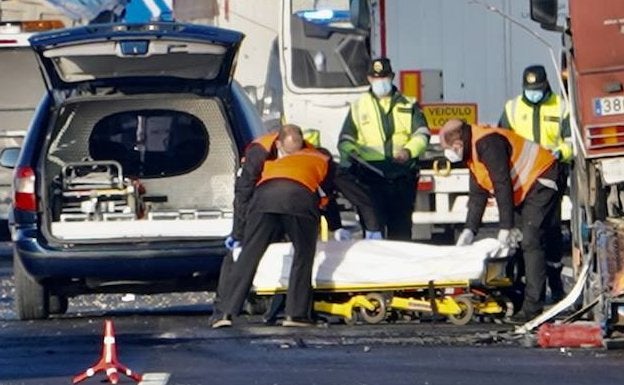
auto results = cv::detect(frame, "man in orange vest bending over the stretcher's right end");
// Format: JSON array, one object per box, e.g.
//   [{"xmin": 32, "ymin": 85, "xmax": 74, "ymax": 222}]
[{"xmin": 440, "ymin": 119, "xmax": 558, "ymax": 323}]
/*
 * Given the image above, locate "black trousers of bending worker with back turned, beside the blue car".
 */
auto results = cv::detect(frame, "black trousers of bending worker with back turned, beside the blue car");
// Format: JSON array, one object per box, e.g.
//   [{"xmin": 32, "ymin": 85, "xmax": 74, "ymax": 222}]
[{"xmin": 219, "ymin": 210, "xmax": 319, "ymax": 319}]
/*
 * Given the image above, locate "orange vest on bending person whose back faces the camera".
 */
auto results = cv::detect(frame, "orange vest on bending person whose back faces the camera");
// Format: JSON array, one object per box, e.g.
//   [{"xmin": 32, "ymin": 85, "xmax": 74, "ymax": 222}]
[{"xmin": 256, "ymin": 148, "xmax": 329, "ymax": 193}]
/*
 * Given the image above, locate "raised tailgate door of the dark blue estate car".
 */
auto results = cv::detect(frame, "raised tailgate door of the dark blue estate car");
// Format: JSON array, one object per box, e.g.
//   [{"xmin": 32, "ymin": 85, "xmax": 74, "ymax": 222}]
[{"xmin": 30, "ymin": 23, "xmax": 244, "ymax": 90}]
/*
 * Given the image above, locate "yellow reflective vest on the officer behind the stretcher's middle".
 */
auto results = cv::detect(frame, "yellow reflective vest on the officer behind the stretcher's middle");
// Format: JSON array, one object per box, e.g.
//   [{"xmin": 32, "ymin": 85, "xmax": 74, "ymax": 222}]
[{"xmin": 351, "ymin": 93, "xmax": 414, "ymax": 161}]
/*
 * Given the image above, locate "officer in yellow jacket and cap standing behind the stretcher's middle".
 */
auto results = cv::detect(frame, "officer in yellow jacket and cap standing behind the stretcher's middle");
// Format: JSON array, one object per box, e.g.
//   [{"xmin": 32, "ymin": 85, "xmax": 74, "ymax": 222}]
[{"xmin": 337, "ymin": 58, "xmax": 431, "ymax": 241}]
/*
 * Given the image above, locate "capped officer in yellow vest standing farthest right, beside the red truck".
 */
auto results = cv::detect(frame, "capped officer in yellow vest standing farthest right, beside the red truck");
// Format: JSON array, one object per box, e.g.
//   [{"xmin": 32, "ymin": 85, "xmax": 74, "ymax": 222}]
[{"xmin": 498, "ymin": 65, "xmax": 573, "ymax": 302}]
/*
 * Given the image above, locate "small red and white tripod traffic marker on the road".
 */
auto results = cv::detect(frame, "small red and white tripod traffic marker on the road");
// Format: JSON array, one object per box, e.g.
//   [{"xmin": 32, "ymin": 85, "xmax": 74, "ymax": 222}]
[{"xmin": 73, "ymin": 320, "xmax": 143, "ymax": 384}]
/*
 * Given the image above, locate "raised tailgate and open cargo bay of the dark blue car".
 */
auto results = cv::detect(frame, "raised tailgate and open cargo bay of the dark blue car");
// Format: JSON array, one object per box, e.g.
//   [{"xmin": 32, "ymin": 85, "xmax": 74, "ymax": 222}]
[{"xmin": 30, "ymin": 23, "xmax": 243, "ymax": 242}]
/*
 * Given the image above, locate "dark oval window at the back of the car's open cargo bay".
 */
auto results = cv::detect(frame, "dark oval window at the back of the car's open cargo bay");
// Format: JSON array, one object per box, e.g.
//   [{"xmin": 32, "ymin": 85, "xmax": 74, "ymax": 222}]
[{"xmin": 89, "ymin": 110, "xmax": 210, "ymax": 178}]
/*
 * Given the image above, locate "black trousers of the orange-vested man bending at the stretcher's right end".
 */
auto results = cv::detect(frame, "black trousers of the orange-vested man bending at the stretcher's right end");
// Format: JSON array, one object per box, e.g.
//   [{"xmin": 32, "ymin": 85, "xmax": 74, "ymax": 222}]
[{"xmin": 519, "ymin": 178, "xmax": 561, "ymax": 315}]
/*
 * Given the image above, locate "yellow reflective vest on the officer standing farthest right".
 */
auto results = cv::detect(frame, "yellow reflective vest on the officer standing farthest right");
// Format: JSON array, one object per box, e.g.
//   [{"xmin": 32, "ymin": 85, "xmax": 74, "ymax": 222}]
[{"xmin": 505, "ymin": 94, "xmax": 565, "ymax": 149}]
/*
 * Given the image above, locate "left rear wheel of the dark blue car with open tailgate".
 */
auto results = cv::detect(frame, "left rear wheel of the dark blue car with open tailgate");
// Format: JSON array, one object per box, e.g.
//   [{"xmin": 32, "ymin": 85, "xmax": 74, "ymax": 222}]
[{"xmin": 13, "ymin": 253, "xmax": 48, "ymax": 321}]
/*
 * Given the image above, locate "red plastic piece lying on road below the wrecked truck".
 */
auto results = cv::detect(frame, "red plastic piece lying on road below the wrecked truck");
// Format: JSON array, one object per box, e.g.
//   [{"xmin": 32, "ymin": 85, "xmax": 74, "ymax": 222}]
[{"xmin": 537, "ymin": 323, "xmax": 603, "ymax": 348}]
